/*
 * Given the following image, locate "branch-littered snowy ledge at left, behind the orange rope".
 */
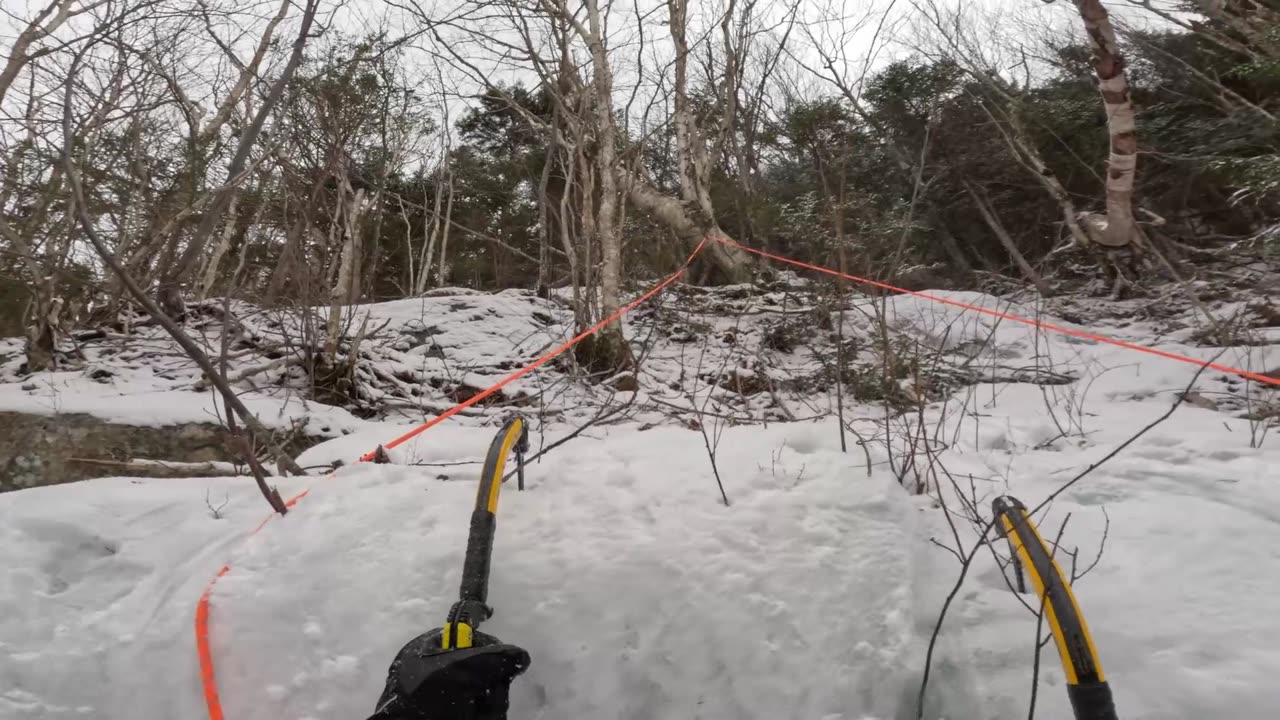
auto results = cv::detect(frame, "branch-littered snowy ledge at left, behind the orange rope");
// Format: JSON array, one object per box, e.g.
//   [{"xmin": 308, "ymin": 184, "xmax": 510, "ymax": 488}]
[{"xmin": 0, "ymin": 288, "xmax": 567, "ymax": 437}]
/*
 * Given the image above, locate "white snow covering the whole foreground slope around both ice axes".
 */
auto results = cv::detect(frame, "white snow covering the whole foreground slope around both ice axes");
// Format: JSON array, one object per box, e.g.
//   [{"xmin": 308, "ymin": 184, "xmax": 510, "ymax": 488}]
[{"xmin": 0, "ymin": 283, "xmax": 1280, "ymax": 720}]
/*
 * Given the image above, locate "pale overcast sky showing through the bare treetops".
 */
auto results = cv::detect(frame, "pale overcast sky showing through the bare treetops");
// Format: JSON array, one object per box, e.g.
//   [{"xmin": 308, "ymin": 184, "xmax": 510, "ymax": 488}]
[{"xmin": 0, "ymin": 0, "xmax": 1187, "ymax": 147}]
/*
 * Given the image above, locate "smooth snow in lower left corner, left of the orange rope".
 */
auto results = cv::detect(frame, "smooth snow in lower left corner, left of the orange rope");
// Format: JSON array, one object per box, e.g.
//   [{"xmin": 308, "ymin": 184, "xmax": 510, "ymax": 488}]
[{"xmin": 0, "ymin": 478, "xmax": 304, "ymax": 720}]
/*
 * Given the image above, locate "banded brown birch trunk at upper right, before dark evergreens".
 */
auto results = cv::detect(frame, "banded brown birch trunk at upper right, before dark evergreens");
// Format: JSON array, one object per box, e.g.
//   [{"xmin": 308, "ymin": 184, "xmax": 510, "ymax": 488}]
[{"xmin": 1076, "ymin": 0, "xmax": 1138, "ymax": 247}]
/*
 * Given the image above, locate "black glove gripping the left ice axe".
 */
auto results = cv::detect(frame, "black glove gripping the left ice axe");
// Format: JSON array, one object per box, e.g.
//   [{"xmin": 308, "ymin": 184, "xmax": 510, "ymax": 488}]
[{"xmin": 369, "ymin": 629, "xmax": 530, "ymax": 720}]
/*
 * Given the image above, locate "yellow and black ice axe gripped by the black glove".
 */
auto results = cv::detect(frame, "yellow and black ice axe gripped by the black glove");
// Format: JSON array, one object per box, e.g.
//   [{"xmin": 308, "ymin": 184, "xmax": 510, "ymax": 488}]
[{"xmin": 442, "ymin": 415, "xmax": 529, "ymax": 650}]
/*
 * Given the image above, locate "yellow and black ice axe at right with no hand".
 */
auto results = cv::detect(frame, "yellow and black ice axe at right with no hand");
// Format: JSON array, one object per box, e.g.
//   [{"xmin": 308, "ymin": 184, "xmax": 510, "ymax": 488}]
[{"xmin": 992, "ymin": 496, "xmax": 1116, "ymax": 720}]
